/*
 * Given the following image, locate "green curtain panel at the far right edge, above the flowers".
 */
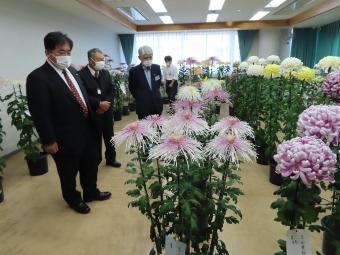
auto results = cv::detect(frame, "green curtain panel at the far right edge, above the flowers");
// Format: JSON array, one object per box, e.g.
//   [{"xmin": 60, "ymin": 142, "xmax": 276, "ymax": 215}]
[{"xmin": 315, "ymin": 21, "xmax": 340, "ymax": 62}]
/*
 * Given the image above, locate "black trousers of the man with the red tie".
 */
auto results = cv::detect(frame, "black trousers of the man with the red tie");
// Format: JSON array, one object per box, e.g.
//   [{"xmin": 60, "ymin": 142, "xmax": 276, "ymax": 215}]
[{"xmin": 52, "ymin": 133, "xmax": 100, "ymax": 205}]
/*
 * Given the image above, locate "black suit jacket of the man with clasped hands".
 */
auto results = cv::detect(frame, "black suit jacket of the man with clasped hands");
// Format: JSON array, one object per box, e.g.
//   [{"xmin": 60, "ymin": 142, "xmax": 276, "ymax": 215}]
[{"xmin": 79, "ymin": 66, "xmax": 114, "ymax": 121}]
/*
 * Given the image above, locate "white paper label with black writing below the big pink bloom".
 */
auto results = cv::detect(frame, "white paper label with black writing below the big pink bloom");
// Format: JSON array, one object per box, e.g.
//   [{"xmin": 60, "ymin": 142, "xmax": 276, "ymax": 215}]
[{"xmin": 287, "ymin": 229, "xmax": 312, "ymax": 255}]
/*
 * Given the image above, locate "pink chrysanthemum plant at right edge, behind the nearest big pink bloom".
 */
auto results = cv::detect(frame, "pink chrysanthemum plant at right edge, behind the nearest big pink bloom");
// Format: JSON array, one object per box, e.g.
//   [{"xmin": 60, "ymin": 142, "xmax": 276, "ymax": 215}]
[{"xmin": 298, "ymin": 105, "xmax": 340, "ymax": 255}]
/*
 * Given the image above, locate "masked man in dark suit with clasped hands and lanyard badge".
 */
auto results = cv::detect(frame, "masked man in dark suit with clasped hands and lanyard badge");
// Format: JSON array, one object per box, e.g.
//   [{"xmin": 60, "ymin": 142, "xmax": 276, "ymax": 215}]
[{"xmin": 79, "ymin": 48, "xmax": 121, "ymax": 167}]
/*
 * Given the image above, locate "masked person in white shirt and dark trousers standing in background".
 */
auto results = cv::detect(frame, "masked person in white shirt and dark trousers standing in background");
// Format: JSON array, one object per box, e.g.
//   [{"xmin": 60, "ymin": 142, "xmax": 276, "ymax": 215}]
[{"xmin": 163, "ymin": 56, "xmax": 178, "ymax": 114}]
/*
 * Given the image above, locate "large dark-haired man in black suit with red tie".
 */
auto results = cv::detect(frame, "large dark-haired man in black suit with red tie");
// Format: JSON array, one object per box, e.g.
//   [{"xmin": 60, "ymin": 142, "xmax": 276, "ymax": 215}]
[{"xmin": 26, "ymin": 32, "xmax": 111, "ymax": 214}]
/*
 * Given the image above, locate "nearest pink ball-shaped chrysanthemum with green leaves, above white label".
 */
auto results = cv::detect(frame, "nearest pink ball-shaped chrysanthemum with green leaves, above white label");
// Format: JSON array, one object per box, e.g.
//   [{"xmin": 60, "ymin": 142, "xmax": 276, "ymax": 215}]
[{"xmin": 271, "ymin": 136, "xmax": 336, "ymax": 254}]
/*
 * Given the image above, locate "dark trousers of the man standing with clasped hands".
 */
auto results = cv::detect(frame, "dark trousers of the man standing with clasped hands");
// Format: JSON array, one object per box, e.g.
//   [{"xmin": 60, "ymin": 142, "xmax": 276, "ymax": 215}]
[{"xmin": 100, "ymin": 113, "xmax": 116, "ymax": 162}]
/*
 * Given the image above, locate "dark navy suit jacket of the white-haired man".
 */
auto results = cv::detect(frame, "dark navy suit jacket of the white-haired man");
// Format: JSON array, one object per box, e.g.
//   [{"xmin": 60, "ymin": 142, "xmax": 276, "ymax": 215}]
[{"xmin": 129, "ymin": 64, "xmax": 163, "ymax": 119}]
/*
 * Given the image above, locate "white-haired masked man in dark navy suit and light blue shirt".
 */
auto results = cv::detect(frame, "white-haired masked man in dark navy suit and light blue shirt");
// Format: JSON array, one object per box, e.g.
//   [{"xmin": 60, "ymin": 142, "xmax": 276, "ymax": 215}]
[{"xmin": 129, "ymin": 46, "xmax": 163, "ymax": 119}]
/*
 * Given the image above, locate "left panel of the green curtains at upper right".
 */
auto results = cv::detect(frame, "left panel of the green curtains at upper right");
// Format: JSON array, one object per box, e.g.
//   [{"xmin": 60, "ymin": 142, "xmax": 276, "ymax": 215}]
[{"xmin": 291, "ymin": 28, "xmax": 318, "ymax": 67}]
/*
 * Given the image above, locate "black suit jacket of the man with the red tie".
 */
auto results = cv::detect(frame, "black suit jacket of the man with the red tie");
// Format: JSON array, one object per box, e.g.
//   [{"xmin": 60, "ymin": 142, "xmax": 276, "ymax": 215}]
[{"xmin": 26, "ymin": 62, "xmax": 99, "ymax": 155}]
